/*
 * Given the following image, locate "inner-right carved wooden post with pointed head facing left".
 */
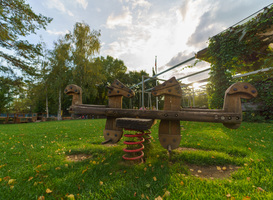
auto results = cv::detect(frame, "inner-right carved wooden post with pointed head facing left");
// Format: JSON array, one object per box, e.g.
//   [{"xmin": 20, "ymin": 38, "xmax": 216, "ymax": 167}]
[{"xmin": 152, "ymin": 77, "xmax": 182, "ymax": 151}]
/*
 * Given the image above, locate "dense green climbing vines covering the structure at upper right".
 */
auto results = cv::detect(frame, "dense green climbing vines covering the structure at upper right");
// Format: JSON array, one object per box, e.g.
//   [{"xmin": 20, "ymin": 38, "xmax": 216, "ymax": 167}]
[{"xmin": 206, "ymin": 7, "xmax": 273, "ymax": 108}]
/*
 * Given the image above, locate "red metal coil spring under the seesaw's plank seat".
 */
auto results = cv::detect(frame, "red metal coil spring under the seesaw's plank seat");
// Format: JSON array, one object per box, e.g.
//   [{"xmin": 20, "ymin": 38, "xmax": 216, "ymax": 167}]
[{"xmin": 122, "ymin": 131, "xmax": 145, "ymax": 160}]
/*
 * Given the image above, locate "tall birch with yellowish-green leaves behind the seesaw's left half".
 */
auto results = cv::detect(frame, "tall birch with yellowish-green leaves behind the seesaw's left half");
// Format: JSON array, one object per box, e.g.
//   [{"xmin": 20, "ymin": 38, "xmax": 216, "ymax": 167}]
[{"xmin": 66, "ymin": 22, "xmax": 103, "ymax": 102}]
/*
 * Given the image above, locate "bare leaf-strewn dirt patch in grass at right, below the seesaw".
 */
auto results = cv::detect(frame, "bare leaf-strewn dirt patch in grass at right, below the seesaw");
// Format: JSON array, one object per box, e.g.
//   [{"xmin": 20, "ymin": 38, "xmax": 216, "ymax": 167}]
[{"xmin": 187, "ymin": 164, "xmax": 240, "ymax": 179}]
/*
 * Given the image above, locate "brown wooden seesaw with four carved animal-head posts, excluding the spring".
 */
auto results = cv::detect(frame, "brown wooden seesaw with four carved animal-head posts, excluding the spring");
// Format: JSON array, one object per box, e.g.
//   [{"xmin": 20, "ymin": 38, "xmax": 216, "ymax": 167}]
[{"xmin": 65, "ymin": 77, "xmax": 258, "ymax": 159}]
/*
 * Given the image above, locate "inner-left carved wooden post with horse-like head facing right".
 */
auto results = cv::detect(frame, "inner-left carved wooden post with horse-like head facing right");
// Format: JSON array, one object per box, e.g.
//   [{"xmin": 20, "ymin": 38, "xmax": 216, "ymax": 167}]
[{"xmin": 103, "ymin": 80, "xmax": 135, "ymax": 144}]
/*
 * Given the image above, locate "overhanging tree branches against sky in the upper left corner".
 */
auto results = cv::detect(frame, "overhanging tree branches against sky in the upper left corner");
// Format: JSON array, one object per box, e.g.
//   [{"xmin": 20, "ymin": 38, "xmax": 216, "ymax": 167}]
[{"xmin": 0, "ymin": 0, "xmax": 52, "ymax": 75}]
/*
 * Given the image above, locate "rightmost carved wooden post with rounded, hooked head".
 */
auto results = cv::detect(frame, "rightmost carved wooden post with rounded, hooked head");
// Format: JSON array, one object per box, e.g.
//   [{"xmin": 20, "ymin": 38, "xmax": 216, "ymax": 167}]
[{"xmin": 223, "ymin": 82, "xmax": 258, "ymax": 129}]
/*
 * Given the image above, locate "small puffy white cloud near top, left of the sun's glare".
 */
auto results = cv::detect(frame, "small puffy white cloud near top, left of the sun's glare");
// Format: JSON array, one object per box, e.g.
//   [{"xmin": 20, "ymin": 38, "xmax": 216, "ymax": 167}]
[{"xmin": 106, "ymin": 7, "xmax": 133, "ymax": 29}]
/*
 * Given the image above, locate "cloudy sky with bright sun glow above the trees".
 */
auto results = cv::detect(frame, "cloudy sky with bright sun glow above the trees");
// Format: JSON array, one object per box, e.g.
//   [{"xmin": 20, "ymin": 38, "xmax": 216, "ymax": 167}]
[{"xmin": 26, "ymin": 0, "xmax": 272, "ymax": 81}]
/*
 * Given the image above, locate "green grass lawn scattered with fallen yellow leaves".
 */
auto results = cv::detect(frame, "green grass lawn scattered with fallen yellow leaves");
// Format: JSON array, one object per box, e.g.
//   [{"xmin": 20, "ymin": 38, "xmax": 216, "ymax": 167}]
[{"xmin": 0, "ymin": 119, "xmax": 273, "ymax": 200}]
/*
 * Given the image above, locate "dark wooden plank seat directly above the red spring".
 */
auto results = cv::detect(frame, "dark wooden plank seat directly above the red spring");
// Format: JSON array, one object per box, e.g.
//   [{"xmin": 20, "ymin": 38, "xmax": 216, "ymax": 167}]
[{"xmin": 116, "ymin": 118, "xmax": 154, "ymax": 131}]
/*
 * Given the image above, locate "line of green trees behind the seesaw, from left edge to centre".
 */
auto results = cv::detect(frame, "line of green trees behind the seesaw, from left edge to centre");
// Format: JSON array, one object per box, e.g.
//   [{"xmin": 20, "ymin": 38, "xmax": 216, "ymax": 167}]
[{"xmin": 0, "ymin": 0, "xmax": 153, "ymax": 118}]
